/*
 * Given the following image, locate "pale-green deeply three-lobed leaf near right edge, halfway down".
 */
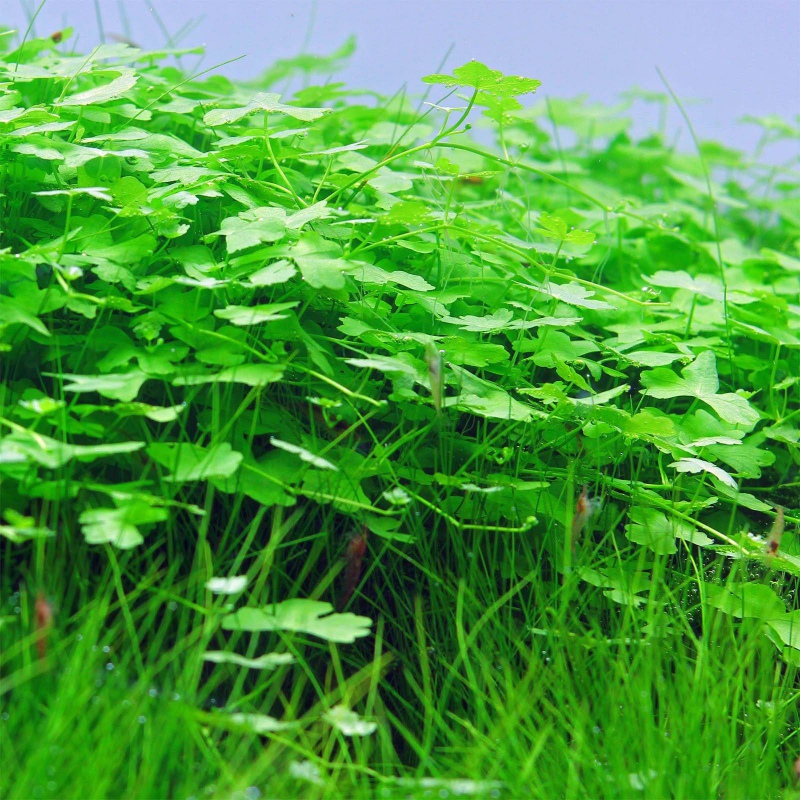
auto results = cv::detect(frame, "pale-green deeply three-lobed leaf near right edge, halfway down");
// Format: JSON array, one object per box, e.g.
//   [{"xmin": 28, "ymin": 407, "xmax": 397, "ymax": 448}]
[{"xmin": 641, "ymin": 350, "xmax": 760, "ymax": 428}]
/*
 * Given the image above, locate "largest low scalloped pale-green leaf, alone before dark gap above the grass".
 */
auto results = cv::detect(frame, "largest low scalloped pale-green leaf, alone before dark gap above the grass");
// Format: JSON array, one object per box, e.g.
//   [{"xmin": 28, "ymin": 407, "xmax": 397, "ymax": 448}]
[{"xmin": 222, "ymin": 599, "xmax": 372, "ymax": 643}]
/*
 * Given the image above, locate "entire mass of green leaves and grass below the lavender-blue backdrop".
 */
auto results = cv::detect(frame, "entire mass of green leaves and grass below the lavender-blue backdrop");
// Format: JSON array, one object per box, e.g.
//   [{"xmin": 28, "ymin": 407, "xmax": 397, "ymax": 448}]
[{"xmin": 0, "ymin": 25, "xmax": 800, "ymax": 800}]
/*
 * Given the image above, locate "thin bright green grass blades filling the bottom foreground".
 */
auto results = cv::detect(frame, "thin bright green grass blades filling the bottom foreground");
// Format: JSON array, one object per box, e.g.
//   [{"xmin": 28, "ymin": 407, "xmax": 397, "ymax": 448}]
[{"xmin": 0, "ymin": 536, "xmax": 798, "ymax": 798}]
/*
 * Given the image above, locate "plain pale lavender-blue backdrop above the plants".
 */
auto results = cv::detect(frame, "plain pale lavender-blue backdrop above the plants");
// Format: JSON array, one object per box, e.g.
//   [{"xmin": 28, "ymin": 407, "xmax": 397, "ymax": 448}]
[{"xmin": 6, "ymin": 0, "xmax": 800, "ymax": 161}]
